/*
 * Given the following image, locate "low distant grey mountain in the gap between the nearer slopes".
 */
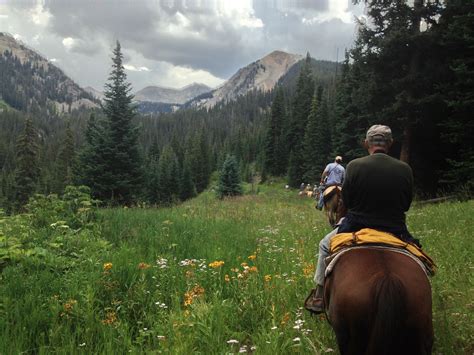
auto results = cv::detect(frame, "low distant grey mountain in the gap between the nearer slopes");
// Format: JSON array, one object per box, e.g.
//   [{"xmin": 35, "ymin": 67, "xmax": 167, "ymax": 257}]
[{"xmin": 135, "ymin": 83, "xmax": 212, "ymax": 105}]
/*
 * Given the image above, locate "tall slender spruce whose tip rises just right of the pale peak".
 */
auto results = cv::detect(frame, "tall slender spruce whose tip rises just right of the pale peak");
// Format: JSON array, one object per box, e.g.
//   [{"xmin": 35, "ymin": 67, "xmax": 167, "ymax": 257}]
[{"xmin": 286, "ymin": 53, "xmax": 314, "ymax": 187}]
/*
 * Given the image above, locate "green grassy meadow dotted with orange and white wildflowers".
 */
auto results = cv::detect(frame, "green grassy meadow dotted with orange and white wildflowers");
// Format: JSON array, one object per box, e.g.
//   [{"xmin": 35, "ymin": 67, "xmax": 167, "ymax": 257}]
[{"xmin": 0, "ymin": 186, "xmax": 474, "ymax": 354}]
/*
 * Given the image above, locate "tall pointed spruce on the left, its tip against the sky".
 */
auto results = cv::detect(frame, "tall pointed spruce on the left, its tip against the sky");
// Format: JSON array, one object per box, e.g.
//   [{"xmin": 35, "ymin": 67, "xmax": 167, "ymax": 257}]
[{"xmin": 99, "ymin": 41, "xmax": 142, "ymax": 204}]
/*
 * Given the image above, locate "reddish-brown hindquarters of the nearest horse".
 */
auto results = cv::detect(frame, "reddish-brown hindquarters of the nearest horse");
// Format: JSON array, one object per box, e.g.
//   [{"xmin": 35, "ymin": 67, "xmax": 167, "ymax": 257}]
[{"xmin": 324, "ymin": 248, "xmax": 433, "ymax": 355}]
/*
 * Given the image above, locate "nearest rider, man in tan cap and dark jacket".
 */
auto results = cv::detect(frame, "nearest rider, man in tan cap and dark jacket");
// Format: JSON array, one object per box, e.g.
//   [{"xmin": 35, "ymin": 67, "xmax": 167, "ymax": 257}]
[{"xmin": 305, "ymin": 125, "xmax": 418, "ymax": 313}]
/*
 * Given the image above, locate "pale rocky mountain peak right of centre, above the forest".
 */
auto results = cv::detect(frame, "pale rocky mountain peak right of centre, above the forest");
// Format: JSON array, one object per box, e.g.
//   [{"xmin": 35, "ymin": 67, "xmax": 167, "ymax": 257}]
[{"xmin": 189, "ymin": 51, "xmax": 303, "ymax": 108}]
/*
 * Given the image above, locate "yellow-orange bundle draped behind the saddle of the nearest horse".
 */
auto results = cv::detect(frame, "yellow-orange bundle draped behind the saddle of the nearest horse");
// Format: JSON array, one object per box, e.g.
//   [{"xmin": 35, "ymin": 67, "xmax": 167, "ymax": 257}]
[{"xmin": 330, "ymin": 228, "xmax": 436, "ymax": 275}]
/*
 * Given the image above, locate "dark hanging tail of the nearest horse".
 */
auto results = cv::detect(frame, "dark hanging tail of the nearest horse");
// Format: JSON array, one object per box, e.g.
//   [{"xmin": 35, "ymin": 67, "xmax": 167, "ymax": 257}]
[{"xmin": 367, "ymin": 274, "xmax": 407, "ymax": 355}]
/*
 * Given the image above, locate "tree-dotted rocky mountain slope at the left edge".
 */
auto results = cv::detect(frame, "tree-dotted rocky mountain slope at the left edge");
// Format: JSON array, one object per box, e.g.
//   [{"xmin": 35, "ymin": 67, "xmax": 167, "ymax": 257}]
[{"xmin": 0, "ymin": 32, "xmax": 98, "ymax": 112}]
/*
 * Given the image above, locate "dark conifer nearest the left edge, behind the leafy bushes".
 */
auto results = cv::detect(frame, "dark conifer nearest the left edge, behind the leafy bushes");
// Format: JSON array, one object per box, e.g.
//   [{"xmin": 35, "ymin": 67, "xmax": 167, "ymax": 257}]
[{"xmin": 15, "ymin": 118, "xmax": 40, "ymax": 209}]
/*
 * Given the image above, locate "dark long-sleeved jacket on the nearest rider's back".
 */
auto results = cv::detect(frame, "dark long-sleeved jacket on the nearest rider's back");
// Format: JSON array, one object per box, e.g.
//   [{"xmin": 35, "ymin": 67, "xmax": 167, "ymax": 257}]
[{"xmin": 342, "ymin": 153, "xmax": 413, "ymax": 226}]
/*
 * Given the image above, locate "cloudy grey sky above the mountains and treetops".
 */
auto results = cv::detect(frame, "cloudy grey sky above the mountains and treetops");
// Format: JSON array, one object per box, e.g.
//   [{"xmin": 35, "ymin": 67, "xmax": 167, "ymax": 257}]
[{"xmin": 0, "ymin": 0, "xmax": 364, "ymax": 91}]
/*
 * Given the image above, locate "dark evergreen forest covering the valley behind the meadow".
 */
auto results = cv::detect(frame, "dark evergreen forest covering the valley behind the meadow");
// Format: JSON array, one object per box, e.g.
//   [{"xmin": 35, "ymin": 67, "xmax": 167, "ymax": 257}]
[{"xmin": 0, "ymin": 0, "xmax": 474, "ymax": 213}]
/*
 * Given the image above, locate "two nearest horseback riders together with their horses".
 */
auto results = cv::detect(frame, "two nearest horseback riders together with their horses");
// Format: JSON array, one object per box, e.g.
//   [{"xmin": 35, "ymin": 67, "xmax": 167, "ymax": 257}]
[{"xmin": 304, "ymin": 125, "xmax": 435, "ymax": 354}]
